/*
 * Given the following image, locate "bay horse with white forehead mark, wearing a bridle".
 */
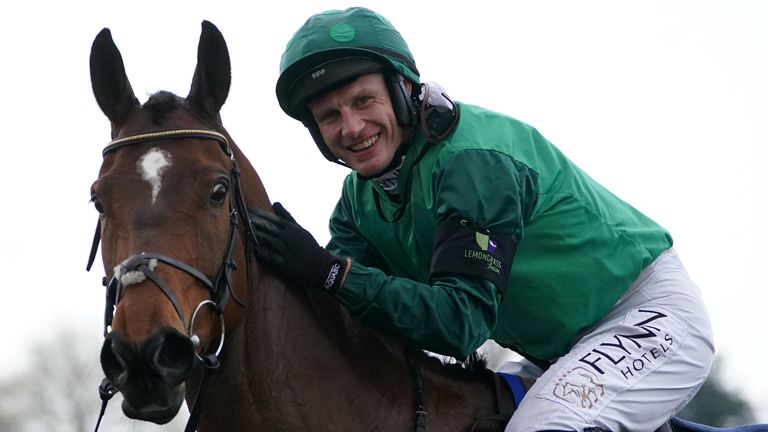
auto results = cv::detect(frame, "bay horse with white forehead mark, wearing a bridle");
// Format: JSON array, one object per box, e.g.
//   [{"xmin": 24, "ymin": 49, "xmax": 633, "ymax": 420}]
[{"xmin": 88, "ymin": 21, "xmax": 764, "ymax": 432}]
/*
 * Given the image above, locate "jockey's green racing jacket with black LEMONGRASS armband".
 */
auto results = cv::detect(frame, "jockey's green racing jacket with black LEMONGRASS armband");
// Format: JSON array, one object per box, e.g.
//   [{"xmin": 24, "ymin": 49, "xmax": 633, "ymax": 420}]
[{"xmin": 327, "ymin": 103, "xmax": 672, "ymax": 361}]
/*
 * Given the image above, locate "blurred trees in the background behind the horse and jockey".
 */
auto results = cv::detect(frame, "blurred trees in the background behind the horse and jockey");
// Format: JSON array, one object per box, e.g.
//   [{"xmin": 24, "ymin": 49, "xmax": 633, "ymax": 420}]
[{"xmin": 0, "ymin": 331, "xmax": 755, "ymax": 432}]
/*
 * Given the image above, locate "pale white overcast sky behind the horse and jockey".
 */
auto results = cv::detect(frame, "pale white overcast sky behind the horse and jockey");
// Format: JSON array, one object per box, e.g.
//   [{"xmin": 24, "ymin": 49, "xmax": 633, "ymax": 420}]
[{"xmin": 0, "ymin": 0, "xmax": 768, "ymax": 422}]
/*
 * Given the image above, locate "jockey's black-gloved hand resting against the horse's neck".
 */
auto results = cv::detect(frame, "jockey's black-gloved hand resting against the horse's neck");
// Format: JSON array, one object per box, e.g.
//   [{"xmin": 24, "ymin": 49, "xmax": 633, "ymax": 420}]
[{"xmin": 248, "ymin": 202, "xmax": 348, "ymax": 293}]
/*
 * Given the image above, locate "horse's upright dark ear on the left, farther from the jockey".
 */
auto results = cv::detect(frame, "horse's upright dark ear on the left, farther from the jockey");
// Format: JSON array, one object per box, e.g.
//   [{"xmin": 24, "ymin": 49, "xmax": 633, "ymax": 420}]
[{"xmin": 90, "ymin": 28, "xmax": 139, "ymax": 123}]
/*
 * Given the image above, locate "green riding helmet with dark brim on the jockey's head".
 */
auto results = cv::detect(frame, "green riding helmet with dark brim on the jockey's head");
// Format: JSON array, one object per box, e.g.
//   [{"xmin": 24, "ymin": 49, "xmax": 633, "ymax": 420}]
[{"xmin": 276, "ymin": 7, "xmax": 420, "ymax": 123}]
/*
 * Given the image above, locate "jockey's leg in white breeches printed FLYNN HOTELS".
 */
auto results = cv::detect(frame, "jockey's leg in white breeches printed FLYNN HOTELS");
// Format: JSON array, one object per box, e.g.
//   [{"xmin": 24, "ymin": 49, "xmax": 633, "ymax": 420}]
[{"xmin": 505, "ymin": 250, "xmax": 714, "ymax": 432}]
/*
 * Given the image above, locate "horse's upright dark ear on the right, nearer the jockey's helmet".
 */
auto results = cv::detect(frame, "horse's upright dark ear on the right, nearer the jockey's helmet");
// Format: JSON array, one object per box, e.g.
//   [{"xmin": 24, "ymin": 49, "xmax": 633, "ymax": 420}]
[{"xmin": 187, "ymin": 21, "xmax": 232, "ymax": 119}]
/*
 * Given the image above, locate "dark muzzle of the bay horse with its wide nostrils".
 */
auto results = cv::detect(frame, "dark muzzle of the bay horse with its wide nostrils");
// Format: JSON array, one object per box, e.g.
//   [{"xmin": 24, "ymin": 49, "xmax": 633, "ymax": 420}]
[{"xmin": 101, "ymin": 327, "xmax": 195, "ymax": 424}]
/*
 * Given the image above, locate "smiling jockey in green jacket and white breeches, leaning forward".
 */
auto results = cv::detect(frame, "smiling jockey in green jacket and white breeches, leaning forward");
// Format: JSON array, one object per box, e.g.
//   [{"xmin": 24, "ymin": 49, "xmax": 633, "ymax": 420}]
[{"xmin": 251, "ymin": 7, "xmax": 714, "ymax": 432}]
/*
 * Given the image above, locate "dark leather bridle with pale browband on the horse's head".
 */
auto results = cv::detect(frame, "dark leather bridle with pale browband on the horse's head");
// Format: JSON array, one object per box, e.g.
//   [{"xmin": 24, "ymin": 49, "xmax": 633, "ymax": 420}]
[{"xmin": 86, "ymin": 129, "xmax": 257, "ymax": 432}]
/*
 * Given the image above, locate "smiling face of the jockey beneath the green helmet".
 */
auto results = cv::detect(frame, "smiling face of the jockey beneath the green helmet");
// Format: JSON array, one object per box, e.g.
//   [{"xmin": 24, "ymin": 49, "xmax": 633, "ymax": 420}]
[{"xmin": 308, "ymin": 73, "xmax": 410, "ymax": 176}]
